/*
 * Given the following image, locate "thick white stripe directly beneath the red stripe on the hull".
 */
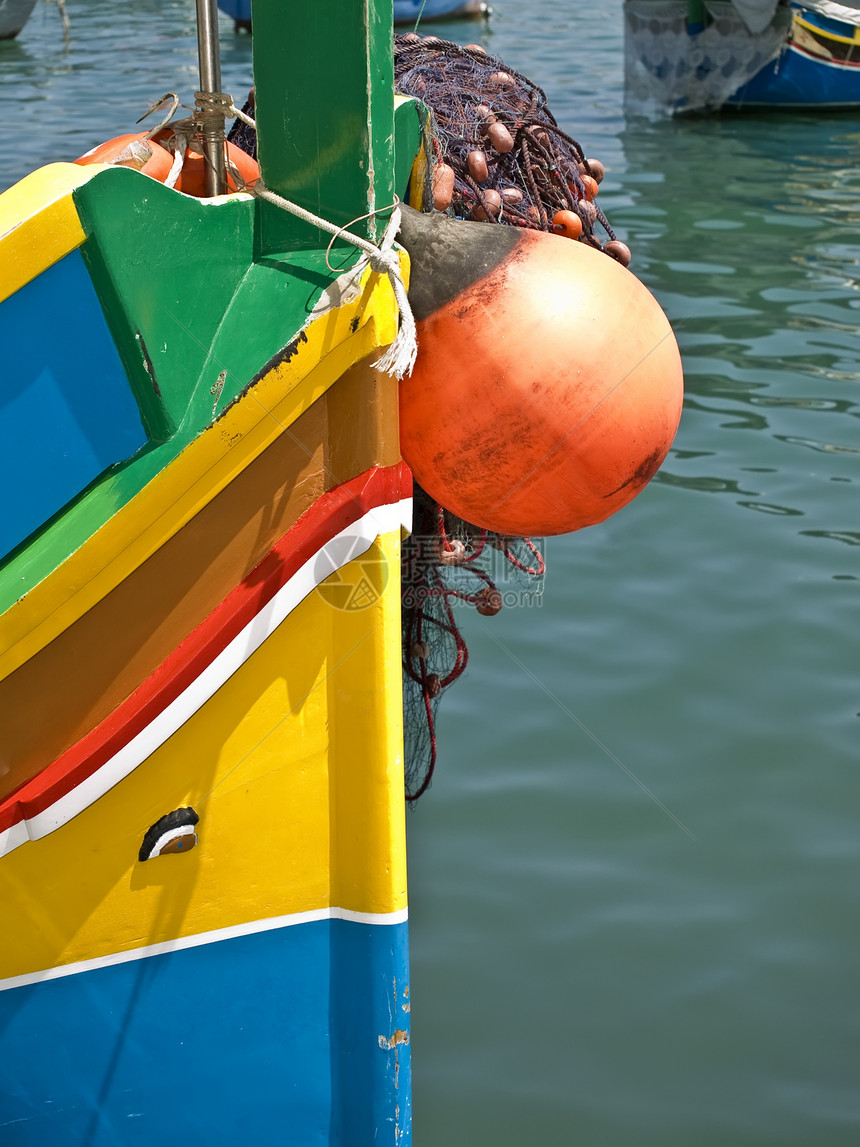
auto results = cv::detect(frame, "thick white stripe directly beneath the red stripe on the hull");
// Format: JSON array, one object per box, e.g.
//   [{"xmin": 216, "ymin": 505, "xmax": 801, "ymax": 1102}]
[{"xmin": 0, "ymin": 498, "xmax": 412, "ymax": 857}]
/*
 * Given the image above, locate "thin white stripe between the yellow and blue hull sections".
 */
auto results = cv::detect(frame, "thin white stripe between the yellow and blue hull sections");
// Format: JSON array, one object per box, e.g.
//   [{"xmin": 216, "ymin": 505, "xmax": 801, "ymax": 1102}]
[{"xmin": 0, "ymin": 908, "xmax": 408, "ymax": 992}]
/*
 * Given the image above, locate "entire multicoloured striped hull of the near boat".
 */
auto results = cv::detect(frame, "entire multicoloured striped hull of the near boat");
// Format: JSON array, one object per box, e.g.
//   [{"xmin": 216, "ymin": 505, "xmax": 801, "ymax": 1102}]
[{"xmin": 0, "ymin": 5, "xmax": 426, "ymax": 1133}]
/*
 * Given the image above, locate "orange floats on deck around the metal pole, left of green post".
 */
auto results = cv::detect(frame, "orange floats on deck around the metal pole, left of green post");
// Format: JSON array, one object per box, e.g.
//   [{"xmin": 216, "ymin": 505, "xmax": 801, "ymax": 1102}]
[{"xmin": 73, "ymin": 127, "xmax": 260, "ymax": 198}]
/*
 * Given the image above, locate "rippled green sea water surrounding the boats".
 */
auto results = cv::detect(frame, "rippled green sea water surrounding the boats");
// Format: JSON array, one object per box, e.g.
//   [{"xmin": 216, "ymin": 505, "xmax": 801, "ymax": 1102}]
[{"xmin": 0, "ymin": 0, "xmax": 860, "ymax": 1147}]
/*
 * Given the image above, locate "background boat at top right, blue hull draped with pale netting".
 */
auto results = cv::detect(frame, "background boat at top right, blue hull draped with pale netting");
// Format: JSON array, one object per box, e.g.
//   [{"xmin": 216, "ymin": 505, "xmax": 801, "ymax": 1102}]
[{"xmin": 625, "ymin": 0, "xmax": 860, "ymax": 114}]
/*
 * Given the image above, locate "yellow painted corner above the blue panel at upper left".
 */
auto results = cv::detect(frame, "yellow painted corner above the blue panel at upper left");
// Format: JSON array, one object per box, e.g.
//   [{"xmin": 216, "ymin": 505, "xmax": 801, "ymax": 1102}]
[{"xmin": 0, "ymin": 163, "xmax": 104, "ymax": 303}]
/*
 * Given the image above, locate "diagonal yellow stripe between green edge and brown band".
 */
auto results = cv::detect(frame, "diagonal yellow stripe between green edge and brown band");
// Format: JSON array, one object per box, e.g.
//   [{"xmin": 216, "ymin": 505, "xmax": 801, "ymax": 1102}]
[{"xmin": 0, "ymin": 252, "xmax": 408, "ymax": 679}]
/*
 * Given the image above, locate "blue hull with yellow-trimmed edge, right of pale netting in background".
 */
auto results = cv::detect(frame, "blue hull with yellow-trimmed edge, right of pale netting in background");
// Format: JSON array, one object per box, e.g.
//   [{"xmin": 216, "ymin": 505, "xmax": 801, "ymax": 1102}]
[{"xmin": 727, "ymin": 6, "xmax": 860, "ymax": 108}]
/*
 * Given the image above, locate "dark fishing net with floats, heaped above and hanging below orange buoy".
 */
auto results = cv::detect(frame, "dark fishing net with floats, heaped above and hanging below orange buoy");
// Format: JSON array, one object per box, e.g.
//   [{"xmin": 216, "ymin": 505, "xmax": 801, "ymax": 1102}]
[{"xmin": 229, "ymin": 33, "xmax": 630, "ymax": 801}]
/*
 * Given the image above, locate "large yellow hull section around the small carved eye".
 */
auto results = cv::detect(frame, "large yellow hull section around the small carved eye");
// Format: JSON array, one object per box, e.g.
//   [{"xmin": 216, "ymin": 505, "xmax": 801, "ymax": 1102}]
[{"xmin": 0, "ymin": 531, "xmax": 406, "ymax": 980}]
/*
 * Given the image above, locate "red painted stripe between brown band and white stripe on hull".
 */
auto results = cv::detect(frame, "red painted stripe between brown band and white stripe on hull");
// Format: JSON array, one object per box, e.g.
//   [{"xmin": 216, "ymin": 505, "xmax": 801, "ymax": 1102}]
[{"xmin": 0, "ymin": 462, "xmax": 412, "ymax": 832}]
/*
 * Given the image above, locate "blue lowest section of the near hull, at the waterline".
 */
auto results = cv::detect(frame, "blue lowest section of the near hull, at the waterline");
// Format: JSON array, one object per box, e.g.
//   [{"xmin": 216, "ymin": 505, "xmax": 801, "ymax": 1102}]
[{"xmin": 0, "ymin": 919, "xmax": 411, "ymax": 1147}]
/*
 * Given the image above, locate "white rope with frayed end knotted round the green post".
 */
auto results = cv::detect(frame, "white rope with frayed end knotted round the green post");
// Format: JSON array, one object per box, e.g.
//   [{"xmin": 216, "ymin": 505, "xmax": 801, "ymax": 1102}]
[{"xmin": 227, "ymin": 106, "xmax": 419, "ymax": 379}]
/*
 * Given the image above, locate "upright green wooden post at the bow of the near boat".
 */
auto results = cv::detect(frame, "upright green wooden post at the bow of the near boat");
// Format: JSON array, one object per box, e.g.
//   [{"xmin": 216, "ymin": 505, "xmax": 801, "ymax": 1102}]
[{"xmin": 252, "ymin": 0, "xmax": 394, "ymax": 256}]
